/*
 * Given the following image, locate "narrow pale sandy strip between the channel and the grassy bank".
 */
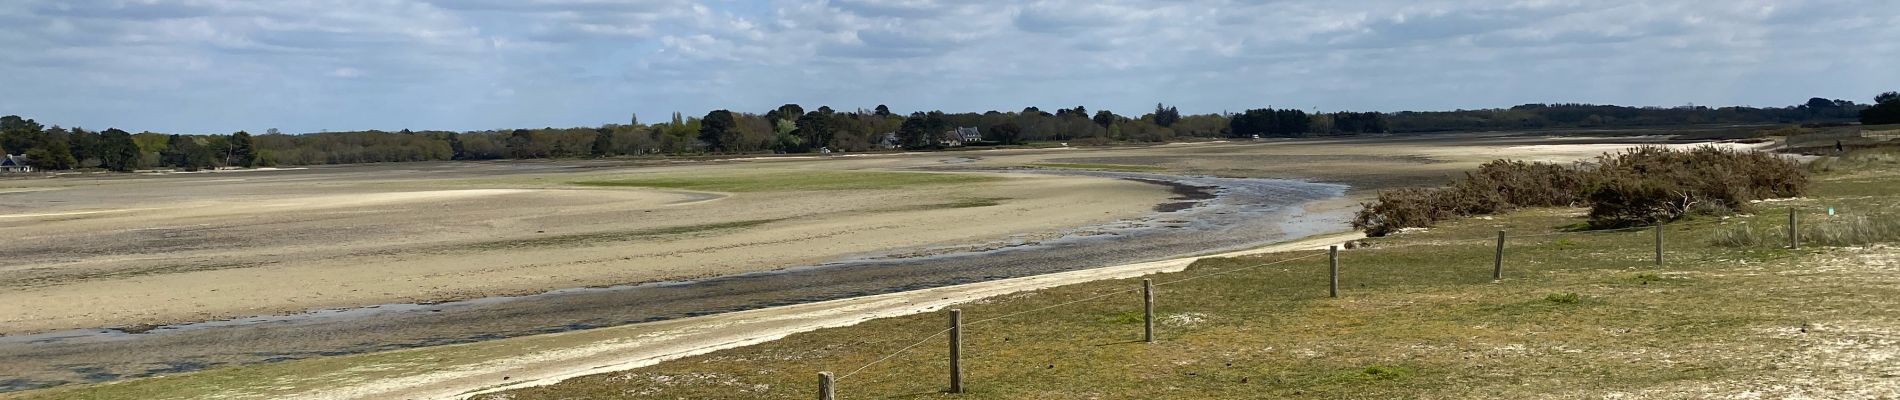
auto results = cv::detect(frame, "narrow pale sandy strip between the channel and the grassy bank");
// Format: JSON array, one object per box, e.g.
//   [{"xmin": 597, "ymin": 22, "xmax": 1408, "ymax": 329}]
[{"xmin": 229, "ymin": 233, "xmax": 1364, "ymax": 398}]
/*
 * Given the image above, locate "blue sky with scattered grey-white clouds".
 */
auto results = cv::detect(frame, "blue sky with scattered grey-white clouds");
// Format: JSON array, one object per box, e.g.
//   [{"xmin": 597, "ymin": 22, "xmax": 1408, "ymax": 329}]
[{"xmin": 0, "ymin": 0, "xmax": 1900, "ymax": 133}]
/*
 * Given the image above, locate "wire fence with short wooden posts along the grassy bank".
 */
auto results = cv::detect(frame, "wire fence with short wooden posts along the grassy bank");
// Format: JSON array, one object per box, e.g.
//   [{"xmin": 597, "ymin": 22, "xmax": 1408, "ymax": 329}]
[{"xmin": 798, "ymin": 209, "xmax": 1799, "ymax": 400}]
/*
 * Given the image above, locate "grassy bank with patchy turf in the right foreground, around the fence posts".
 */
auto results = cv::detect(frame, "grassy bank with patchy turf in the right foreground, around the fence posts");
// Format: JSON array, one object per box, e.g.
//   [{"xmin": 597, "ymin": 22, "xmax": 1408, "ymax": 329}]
[{"xmin": 486, "ymin": 156, "xmax": 1900, "ymax": 398}]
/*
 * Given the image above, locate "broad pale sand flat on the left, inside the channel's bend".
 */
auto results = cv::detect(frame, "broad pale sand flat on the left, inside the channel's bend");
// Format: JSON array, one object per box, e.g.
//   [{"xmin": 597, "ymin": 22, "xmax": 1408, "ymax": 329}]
[{"xmin": 0, "ymin": 161, "xmax": 1169, "ymax": 334}]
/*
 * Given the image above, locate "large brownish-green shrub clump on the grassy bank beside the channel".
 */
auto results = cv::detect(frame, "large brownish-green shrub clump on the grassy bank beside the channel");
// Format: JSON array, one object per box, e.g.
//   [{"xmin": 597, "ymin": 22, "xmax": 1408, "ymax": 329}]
[{"xmin": 1353, "ymin": 146, "xmax": 1809, "ymax": 237}]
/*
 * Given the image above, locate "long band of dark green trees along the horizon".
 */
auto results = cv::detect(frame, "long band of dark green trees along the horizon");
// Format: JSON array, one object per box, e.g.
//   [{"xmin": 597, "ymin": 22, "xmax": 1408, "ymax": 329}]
[{"xmin": 0, "ymin": 93, "xmax": 1900, "ymax": 171}]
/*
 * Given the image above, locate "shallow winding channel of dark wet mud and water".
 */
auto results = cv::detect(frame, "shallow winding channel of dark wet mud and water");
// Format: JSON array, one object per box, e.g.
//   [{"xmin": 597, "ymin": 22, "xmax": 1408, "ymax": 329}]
[{"xmin": 0, "ymin": 171, "xmax": 1347, "ymax": 391}]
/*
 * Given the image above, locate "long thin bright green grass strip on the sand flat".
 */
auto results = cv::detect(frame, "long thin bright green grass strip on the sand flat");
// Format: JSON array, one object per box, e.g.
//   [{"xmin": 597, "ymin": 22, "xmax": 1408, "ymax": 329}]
[{"xmin": 572, "ymin": 171, "xmax": 999, "ymax": 191}]
